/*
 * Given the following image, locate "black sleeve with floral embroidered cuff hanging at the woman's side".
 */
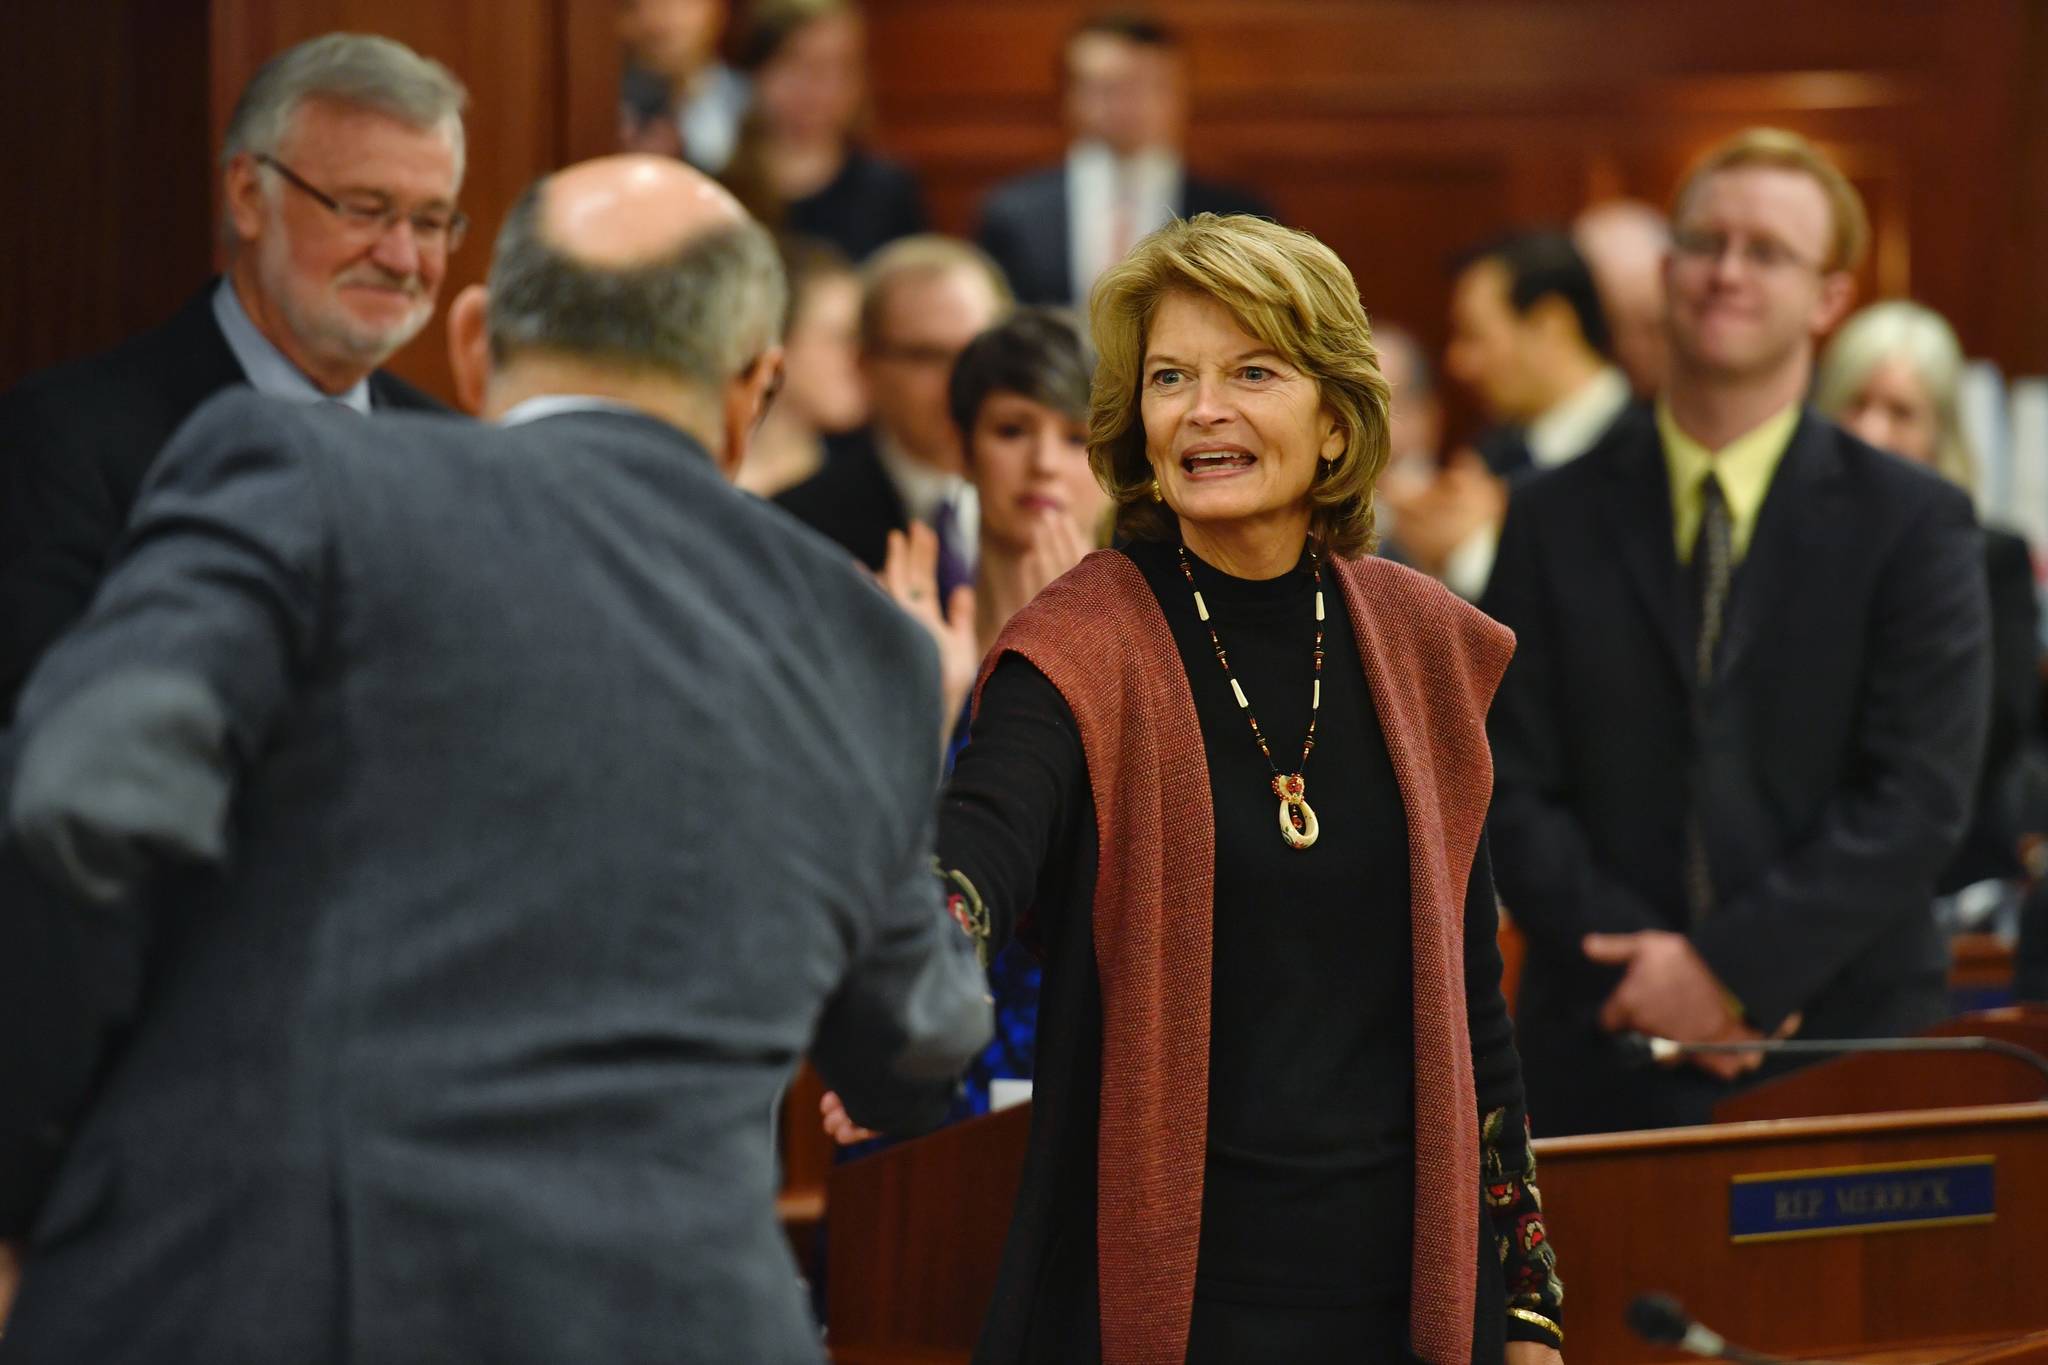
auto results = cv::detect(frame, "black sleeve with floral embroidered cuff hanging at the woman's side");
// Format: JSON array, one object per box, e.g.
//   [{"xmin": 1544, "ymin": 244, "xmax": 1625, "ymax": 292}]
[{"xmin": 1464, "ymin": 841, "xmax": 1565, "ymax": 1349}]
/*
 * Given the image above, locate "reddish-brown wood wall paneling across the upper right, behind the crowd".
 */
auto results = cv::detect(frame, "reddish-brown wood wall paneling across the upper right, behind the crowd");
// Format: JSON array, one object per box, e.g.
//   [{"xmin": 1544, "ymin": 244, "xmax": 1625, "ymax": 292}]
[{"xmin": 868, "ymin": 0, "xmax": 2048, "ymax": 384}]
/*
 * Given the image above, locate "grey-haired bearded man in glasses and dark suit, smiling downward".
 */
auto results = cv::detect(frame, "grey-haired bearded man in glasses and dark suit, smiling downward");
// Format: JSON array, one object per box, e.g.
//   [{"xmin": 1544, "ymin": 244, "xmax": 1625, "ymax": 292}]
[{"xmin": 0, "ymin": 33, "xmax": 467, "ymax": 720}]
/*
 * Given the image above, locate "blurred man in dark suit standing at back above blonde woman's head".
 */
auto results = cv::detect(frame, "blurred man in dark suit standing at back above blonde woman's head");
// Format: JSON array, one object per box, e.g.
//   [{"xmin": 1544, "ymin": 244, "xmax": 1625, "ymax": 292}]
[{"xmin": 979, "ymin": 10, "xmax": 1272, "ymax": 303}]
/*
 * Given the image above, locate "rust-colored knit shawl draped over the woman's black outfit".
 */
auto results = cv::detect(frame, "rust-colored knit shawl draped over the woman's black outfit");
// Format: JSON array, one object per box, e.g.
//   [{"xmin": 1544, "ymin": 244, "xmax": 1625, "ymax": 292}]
[{"xmin": 981, "ymin": 551, "xmax": 1513, "ymax": 1365}]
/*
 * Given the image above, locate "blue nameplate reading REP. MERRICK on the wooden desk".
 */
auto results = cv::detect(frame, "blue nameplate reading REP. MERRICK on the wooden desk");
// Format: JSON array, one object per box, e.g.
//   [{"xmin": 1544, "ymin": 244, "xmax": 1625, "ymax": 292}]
[{"xmin": 1729, "ymin": 1156, "xmax": 1997, "ymax": 1242}]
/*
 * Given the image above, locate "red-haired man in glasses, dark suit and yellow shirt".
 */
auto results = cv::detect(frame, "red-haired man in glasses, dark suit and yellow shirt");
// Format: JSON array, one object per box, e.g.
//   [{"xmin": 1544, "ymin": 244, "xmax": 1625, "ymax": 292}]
[{"xmin": 1483, "ymin": 129, "xmax": 1991, "ymax": 1134}]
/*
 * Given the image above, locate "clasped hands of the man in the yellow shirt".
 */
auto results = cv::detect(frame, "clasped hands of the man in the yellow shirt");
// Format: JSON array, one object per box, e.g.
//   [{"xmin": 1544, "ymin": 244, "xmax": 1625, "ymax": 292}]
[{"xmin": 1579, "ymin": 929, "xmax": 1800, "ymax": 1081}]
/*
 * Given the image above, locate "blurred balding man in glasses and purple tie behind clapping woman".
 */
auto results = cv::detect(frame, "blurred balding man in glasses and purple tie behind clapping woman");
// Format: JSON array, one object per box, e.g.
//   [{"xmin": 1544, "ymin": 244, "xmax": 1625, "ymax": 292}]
[{"xmin": 776, "ymin": 233, "xmax": 1010, "ymax": 596}]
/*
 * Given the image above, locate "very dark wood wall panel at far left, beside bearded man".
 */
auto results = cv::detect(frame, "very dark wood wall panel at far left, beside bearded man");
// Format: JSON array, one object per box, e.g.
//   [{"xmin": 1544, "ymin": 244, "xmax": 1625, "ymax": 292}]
[{"xmin": 0, "ymin": 0, "xmax": 213, "ymax": 389}]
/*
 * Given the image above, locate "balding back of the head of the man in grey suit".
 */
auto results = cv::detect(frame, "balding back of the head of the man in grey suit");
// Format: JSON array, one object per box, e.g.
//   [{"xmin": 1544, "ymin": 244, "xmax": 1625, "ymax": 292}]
[{"xmin": 487, "ymin": 156, "xmax": 786, "ymax": 389}]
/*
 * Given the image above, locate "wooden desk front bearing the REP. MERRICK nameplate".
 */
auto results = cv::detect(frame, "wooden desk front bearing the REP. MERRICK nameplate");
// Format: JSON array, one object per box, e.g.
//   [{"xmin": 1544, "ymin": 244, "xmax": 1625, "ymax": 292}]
[{"xmin": 1536, "ymin": 1103, "xmax": 2048, "ymax": 1363}]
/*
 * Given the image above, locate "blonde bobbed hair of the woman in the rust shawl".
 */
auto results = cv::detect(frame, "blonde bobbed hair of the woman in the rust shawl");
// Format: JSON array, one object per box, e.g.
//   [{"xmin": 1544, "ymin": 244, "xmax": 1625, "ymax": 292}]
[{"xmin": 1087, "ymin": 213, "xmax": 1389, "ymax": 557}]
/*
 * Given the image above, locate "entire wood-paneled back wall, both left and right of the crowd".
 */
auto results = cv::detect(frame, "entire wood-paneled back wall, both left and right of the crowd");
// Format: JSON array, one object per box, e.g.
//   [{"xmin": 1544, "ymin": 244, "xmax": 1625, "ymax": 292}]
[{"xmin": 0, "ymin": 0, "xmax": 2048, "ymax": 401}]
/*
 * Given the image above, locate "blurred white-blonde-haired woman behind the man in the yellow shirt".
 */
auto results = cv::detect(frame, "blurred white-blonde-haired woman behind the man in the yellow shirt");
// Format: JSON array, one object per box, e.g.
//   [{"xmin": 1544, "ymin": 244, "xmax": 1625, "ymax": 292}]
[{"xmin": 1815, "ymin": 301, "xmax": 2040, "ymax": 894}]
